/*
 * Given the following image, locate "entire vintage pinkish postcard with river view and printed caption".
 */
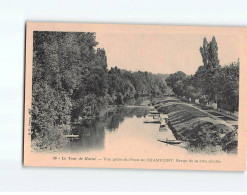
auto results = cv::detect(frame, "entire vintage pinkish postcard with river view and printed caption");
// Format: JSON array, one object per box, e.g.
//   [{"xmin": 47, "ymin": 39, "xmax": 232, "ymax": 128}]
[{"xmin": 24, "ymin": 22, "xmax": 247, "ymax": 171}]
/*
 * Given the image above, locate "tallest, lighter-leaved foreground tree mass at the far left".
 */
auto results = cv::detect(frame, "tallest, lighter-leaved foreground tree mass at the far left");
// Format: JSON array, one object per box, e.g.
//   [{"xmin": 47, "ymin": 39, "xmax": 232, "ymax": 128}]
[{"xmin": 30, "ymin": 31, "xmax": 102, "ymax": 149}]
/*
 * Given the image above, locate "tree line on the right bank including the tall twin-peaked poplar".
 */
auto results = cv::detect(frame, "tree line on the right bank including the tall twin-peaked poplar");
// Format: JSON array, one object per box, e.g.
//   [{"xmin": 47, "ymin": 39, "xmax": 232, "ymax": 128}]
[{"xmin": 166, "ymin": 37, "xmax": 239, "ymax": 112}]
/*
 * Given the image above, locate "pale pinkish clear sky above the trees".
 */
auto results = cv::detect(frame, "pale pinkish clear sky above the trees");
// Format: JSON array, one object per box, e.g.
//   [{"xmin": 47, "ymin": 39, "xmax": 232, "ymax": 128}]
[{"xmin": 96, "ymin": 32, "xmax": 239, "ymax": 75}]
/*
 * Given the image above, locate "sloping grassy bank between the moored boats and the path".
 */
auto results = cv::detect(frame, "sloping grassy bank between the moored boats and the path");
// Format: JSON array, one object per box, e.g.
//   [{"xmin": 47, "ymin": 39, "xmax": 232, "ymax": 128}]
[{"xmin": 156, "ymin": 100, "xmax": 237, "ymax": 153}]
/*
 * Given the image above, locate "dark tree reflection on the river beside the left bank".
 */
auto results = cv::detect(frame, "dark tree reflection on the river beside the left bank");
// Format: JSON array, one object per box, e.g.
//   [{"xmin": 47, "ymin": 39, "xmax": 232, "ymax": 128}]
[{"xmin": 69, "ymin": 107, "xmax": 148, "ymax": 152}]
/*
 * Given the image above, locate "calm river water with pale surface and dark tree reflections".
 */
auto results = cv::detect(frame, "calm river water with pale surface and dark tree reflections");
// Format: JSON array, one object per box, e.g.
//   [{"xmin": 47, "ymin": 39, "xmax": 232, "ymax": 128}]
[{"xmin": 66, "ymin": 106, "xmax": 188, "ymax": 156}]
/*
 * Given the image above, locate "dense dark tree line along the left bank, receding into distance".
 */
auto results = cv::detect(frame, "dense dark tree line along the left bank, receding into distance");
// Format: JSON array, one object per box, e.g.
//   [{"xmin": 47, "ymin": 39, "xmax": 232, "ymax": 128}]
[{"xmin": 30, "ymin": 31, "xmax": 167, "ymax": 149}]
